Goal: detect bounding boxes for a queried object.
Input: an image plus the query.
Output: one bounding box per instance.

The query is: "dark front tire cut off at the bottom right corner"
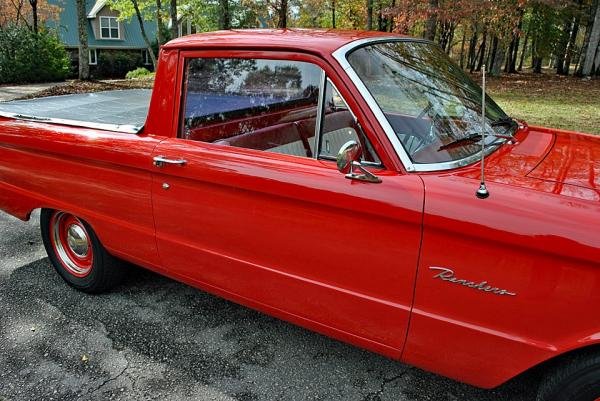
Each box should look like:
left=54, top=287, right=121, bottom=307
left=537, top=351, right=600, bottom=401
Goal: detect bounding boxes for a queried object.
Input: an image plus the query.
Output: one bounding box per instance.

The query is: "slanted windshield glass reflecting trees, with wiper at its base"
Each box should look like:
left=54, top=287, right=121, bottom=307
left=348, top=41, right=516, bottom=163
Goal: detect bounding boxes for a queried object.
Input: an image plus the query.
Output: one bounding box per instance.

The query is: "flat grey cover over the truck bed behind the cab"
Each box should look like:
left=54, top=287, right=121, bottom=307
left=0, top=89, right=152, bottom=134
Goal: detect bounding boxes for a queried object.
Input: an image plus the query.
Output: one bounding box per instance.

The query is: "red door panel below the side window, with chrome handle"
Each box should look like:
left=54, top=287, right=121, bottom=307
left=153, top=139, right=423, bottom=353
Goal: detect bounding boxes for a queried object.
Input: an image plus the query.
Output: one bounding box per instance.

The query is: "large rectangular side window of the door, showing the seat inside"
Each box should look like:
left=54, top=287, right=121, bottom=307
left=179, top=58, right=323, bottom=157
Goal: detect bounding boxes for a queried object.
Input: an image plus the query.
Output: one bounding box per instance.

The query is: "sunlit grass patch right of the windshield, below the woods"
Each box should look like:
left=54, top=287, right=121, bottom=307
left=486, top=73, right=600, bottom=135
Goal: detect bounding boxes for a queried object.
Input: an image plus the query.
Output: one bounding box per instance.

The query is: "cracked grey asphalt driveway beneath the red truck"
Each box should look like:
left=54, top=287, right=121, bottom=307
left=0, top=212, right=535, bottom=401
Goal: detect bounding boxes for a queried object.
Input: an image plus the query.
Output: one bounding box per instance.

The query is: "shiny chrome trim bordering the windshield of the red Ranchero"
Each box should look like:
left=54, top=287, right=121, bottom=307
left=331, top=36, right=500, bottom=172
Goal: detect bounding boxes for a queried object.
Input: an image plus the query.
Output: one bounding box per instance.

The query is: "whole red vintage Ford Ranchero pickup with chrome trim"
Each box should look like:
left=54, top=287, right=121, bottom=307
left=0, top=30, right=600, bottom=401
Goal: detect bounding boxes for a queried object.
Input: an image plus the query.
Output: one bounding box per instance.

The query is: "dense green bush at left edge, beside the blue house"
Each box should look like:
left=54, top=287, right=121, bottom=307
left=0, top=25, right=70, bottom=84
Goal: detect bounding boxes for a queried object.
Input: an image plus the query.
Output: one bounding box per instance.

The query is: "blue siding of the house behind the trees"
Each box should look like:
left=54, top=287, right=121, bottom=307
left=47, top=0, right=156, bottom=49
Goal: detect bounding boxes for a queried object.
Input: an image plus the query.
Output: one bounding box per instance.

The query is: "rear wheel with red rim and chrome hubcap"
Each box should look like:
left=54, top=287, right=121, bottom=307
left=40, top=209, right=123, bottom=294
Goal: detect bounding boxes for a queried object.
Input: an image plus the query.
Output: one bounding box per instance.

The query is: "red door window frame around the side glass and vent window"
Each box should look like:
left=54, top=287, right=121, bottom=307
left=171, top=48, right=398, bottom=170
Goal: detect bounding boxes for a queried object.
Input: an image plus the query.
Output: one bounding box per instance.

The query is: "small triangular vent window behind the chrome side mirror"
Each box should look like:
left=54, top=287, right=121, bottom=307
left=319, top=79, right=381, bottom=164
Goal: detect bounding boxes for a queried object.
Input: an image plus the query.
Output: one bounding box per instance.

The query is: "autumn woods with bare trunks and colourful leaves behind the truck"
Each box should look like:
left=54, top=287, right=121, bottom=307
left=0, top=0, right=600, bottom=77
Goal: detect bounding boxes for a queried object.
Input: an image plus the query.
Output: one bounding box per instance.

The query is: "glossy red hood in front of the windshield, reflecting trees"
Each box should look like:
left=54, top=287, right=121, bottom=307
left=459, top=127, right=600, bottom=201
